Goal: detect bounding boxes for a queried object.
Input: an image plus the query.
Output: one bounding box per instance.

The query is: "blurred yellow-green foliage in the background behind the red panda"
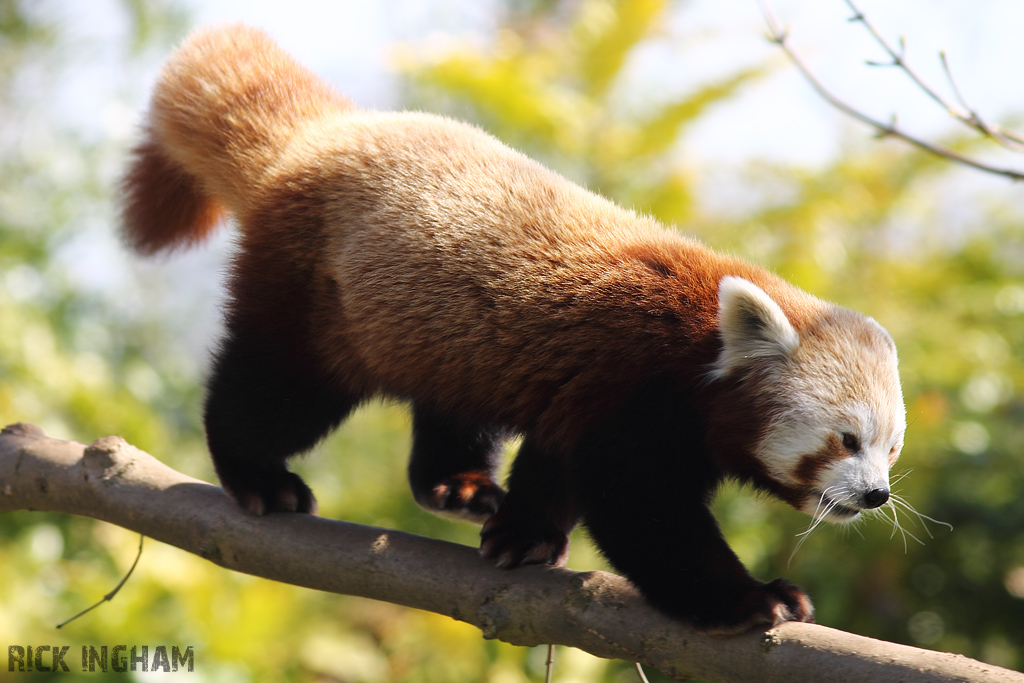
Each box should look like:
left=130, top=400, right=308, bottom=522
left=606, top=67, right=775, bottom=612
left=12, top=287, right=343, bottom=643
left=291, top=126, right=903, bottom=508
left=0, top=0, right=1024, bottom=682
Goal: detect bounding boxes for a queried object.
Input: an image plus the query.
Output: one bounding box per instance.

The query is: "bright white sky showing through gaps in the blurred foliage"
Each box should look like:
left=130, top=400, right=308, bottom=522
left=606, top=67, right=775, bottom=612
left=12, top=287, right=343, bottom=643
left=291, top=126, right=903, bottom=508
left=12, top=0, right=1024, bottom=393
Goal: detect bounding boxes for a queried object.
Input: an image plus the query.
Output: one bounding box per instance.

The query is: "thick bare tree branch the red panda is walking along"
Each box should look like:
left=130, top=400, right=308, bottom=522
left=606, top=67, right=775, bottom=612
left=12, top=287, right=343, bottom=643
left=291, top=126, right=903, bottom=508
left=0, top=425, right=1024, bottom=683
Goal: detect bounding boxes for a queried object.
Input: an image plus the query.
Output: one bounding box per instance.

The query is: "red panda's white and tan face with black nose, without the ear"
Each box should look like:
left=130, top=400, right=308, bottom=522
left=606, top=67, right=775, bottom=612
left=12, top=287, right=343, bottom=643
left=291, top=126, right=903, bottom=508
left=741, top=301, right=906, bottom=521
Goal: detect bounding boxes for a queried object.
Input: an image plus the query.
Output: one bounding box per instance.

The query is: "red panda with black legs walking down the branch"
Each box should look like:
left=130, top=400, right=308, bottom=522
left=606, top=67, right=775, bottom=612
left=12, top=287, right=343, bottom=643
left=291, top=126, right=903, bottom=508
left=123, top=26, right=905, bottom=633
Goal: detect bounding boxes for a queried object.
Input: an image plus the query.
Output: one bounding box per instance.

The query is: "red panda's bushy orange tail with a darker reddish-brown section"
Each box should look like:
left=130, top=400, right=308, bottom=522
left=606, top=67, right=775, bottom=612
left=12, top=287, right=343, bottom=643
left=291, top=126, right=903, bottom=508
left=122, top=26, right=351, bottom=254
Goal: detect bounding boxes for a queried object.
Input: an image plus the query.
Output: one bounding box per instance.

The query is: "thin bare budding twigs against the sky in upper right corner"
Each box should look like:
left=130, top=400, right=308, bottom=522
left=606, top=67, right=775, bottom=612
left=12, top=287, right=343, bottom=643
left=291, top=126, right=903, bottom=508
left=761, top=0, right=1024, bottom=180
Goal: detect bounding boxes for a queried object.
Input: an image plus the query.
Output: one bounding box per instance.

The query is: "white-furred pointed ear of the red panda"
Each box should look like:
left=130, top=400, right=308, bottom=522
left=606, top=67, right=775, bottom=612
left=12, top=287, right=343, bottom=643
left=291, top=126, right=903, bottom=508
left=714, top=275, right=800, bottom=377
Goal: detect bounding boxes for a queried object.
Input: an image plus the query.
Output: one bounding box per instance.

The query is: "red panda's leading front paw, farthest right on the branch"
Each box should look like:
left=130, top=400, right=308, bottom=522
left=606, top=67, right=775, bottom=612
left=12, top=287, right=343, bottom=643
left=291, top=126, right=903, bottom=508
left=691, top=579, right=814, bottom=636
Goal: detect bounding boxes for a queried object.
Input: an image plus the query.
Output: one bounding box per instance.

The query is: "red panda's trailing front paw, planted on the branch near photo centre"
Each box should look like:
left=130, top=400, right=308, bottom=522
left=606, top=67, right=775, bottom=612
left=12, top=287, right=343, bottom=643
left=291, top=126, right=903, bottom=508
left=480, top=507, right=569, bottom=569
